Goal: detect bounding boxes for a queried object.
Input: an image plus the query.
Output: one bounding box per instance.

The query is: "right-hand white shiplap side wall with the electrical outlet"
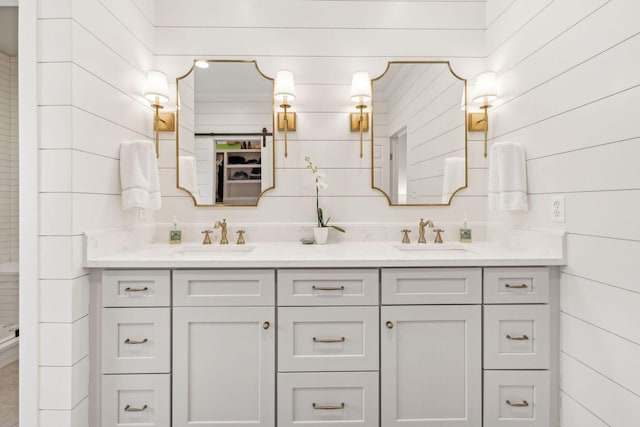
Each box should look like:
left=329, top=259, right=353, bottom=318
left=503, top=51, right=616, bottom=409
left=487, top=0, right=640, bottom=427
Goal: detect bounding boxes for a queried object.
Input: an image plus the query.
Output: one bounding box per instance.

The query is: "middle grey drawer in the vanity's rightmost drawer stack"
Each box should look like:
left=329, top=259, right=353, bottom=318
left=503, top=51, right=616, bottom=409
left=484, top=305, right=551, bottom=369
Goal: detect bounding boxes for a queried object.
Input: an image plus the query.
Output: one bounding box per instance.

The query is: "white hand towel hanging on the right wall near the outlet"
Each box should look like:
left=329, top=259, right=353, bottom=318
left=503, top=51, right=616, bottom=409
left=489, top=142, right=529, bottom=211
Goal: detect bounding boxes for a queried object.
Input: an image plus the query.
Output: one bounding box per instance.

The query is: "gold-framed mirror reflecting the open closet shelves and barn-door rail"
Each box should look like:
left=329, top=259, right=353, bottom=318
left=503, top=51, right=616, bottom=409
left=176, top=60, right=275, bottom=206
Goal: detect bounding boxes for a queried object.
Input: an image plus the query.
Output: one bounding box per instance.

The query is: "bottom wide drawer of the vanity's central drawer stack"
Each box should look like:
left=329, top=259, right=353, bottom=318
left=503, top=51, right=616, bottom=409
left=278, top=372, right=378, bottom=427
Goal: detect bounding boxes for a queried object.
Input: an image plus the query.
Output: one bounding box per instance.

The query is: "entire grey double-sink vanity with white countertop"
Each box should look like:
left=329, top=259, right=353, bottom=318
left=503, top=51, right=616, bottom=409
left=88, top=234, right=563, bottom=427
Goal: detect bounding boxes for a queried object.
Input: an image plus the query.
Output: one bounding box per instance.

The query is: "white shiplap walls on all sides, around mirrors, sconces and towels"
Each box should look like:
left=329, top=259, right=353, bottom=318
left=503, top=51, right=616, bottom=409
left=31, top=0, right=640, bottom=427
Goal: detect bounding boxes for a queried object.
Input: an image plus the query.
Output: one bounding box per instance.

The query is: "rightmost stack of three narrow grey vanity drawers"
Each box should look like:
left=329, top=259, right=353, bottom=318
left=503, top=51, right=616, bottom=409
left=483, top=267, right=552, bottom=427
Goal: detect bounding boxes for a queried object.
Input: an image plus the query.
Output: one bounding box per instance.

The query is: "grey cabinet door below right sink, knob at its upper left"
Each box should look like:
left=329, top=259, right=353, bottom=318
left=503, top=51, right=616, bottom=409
left=380, top=305, right=482, bottom=427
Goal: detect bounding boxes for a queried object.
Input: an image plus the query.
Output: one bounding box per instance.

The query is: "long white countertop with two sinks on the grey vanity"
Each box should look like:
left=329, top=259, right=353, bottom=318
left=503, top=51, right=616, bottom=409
left=85, top=241, right=565, bottom=268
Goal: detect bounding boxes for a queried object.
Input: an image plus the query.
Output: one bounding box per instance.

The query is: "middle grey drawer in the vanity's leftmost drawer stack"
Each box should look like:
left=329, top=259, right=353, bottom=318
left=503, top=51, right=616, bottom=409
left=102, top=307, right=171, bottom=374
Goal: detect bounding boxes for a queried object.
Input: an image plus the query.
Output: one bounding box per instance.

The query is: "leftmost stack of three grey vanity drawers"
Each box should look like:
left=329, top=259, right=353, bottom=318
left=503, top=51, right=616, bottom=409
left=100, top=270, right=171, bottom=427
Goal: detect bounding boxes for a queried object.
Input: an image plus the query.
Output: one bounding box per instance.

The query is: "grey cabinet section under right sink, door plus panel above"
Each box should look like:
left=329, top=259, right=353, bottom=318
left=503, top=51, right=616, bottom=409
left=380, top=268, right=482, bottom=427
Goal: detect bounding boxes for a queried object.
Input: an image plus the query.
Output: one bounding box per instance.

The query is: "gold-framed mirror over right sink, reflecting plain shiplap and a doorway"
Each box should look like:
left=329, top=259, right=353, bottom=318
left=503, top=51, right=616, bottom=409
left=371, top=61, right=467, bottom=206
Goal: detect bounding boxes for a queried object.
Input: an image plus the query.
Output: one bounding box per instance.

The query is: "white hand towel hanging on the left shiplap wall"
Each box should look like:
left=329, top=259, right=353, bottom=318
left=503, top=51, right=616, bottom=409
left=120, top=140, right=161, bottom=210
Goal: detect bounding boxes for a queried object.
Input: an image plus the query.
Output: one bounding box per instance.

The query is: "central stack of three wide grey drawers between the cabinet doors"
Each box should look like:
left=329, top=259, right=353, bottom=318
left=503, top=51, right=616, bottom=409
left=277, top=269, right=379, bottom=427
